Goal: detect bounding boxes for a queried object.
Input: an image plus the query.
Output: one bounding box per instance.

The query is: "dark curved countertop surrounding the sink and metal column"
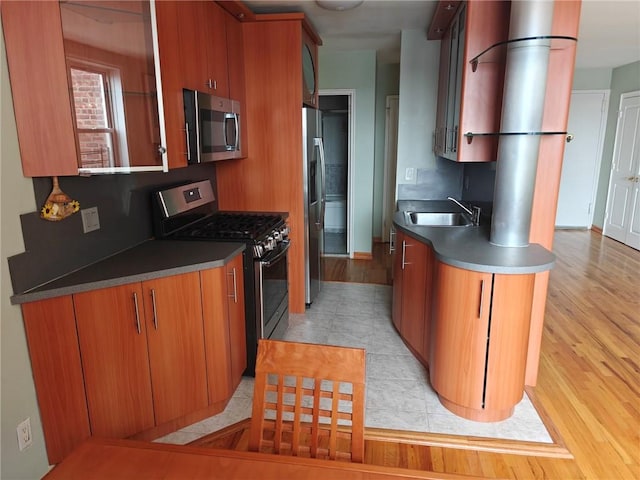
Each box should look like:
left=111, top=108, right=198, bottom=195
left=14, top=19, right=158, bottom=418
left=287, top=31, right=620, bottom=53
left=393, top=200, right=556, bottom=274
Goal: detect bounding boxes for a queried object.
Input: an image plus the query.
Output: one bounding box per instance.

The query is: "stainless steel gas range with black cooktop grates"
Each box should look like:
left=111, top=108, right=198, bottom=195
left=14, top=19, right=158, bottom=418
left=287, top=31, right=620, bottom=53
left=153, top=180, right=291, bottom=375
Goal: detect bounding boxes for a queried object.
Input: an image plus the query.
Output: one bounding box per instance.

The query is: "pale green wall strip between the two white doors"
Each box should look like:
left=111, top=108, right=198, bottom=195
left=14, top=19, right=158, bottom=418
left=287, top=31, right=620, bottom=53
left=593, top=62, right=640, bottom=228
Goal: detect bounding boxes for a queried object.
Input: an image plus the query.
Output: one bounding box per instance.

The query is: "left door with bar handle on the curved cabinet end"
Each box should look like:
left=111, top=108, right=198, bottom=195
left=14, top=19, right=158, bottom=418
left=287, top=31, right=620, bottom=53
left=429, top=262, right=492, bottom=409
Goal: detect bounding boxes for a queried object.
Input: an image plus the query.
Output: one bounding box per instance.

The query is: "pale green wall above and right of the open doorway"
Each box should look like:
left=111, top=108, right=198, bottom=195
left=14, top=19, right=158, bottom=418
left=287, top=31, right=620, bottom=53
left=318, top=47, right=376, bottom=253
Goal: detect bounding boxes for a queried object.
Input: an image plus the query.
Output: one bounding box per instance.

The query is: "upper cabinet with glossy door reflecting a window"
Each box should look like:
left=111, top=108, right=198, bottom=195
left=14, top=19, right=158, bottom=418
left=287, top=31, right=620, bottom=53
left=2, top=1, right=167, bottom=176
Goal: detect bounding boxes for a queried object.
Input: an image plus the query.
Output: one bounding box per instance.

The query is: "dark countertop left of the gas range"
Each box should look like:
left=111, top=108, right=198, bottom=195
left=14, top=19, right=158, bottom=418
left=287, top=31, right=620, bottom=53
left=11, top=240, right=245, bottom=305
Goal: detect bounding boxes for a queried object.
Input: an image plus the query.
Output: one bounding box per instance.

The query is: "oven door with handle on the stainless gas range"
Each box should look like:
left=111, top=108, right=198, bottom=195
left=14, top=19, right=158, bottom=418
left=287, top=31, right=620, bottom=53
left=256, top=240, right=290, bottom=339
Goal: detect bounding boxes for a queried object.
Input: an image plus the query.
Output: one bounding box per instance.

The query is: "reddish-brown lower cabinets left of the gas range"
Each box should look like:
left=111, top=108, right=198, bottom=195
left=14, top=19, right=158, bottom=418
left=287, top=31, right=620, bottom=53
left=22, top=255, right=246, bottom=464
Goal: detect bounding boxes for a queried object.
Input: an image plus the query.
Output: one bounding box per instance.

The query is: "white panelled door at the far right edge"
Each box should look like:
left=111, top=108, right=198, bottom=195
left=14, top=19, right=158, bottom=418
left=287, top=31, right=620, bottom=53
left=604, top=91, right=640, bottom=250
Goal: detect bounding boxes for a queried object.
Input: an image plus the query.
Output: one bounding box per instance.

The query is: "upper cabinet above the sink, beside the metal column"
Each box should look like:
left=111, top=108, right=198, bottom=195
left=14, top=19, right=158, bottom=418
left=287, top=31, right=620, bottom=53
left=433, top=1, right=511, bottom=162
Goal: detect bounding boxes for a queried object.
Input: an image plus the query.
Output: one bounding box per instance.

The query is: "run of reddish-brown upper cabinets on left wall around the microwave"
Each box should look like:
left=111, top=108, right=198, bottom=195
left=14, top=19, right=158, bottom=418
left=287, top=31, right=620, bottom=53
left=1, top=0, right=246, bottom=177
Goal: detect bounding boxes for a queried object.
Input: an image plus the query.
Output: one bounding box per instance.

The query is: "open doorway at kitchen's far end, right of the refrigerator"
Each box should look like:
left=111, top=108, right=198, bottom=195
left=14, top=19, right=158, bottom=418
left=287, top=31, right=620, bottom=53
left=319, top=90, right=353, bottom=256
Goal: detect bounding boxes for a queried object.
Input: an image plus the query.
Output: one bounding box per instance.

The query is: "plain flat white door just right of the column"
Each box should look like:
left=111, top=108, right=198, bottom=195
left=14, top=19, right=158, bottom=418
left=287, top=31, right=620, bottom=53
left=556, top=90, right=609, bottom=228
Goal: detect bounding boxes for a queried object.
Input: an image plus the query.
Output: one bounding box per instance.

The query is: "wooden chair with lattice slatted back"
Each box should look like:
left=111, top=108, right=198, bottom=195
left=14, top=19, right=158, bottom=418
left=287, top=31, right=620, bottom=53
left=249, top=340, right=365, bottom=463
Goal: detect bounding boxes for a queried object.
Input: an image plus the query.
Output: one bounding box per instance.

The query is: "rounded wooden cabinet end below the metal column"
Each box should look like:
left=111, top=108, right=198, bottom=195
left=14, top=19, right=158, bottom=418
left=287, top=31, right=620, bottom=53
left=429, top=262, right=535, bottom=422
